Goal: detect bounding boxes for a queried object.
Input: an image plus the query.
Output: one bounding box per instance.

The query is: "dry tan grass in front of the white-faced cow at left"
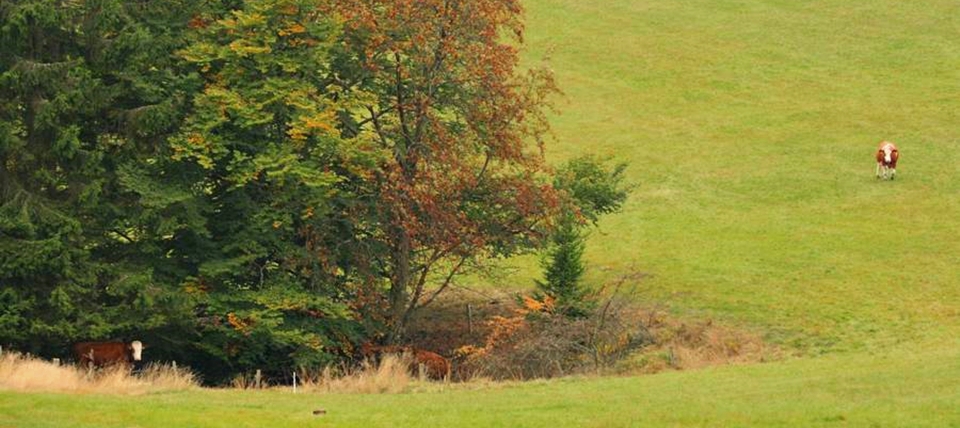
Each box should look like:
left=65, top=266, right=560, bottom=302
left=0, top=352, right=197, bottom=395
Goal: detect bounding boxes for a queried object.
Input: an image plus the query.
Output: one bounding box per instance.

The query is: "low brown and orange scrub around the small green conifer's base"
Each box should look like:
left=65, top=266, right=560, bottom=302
left=457, top=274, right=779, bottom=380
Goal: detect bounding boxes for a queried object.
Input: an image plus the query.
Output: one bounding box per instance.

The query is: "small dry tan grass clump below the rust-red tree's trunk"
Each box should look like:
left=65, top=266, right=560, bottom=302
left=302, top=354, right=416, bottom=394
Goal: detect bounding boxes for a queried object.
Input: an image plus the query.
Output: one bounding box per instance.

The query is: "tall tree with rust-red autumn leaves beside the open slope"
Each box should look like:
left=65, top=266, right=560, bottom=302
left=330, top=0, right=557, bottom=340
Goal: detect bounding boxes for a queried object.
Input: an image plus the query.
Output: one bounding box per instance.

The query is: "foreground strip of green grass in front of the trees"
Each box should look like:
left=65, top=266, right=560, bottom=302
left=0, top=343, right=960, bottom=428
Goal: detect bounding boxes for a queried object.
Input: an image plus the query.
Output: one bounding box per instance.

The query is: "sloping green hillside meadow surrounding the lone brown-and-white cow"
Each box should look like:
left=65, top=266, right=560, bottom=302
left=529, top=0, right=960, bottom=353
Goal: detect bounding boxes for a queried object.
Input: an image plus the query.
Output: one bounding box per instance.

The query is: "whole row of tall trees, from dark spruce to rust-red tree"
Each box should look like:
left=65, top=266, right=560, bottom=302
left=0, top=0, right=622, bottom=380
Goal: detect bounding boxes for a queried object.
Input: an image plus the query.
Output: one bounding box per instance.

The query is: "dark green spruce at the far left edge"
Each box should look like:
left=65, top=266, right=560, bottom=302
left=0, top=0, right=199, bottom=356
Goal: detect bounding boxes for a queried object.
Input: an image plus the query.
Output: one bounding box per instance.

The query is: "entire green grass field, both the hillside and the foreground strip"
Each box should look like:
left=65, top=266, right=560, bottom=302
left=0, top=0, right=960, bottom=427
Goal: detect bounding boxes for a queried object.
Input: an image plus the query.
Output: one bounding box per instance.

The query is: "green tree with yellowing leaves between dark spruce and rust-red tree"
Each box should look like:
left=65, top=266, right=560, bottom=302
left=165, top=0, right=377, bottom=371
